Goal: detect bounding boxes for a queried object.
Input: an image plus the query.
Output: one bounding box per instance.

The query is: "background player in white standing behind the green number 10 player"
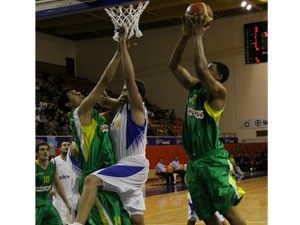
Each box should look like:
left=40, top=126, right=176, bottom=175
left=52, top=141, right=79, bottom=224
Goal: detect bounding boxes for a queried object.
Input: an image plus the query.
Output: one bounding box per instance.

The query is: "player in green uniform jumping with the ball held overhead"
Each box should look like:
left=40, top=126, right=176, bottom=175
left=169, top=17, right=246, bottom=225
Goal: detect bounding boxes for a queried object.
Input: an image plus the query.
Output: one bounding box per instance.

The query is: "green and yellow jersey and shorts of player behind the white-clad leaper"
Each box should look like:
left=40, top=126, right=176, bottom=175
left=68, top=108, right=131, bottom=225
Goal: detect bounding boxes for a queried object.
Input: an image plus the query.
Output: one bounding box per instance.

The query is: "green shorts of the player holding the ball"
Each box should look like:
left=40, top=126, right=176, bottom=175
left=186, top=151, right=245, bottom=220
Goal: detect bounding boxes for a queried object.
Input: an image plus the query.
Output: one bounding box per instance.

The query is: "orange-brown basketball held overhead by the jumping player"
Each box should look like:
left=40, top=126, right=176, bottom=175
left=185, top=2, right=213, bottom=27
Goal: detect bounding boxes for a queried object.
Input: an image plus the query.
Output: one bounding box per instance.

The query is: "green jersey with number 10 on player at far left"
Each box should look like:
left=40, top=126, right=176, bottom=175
left=35, top=161, right=56, bottom=207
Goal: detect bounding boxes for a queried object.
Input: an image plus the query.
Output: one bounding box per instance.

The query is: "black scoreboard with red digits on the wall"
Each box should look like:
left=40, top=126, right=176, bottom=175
left=244, top=21, right=268, bottom=64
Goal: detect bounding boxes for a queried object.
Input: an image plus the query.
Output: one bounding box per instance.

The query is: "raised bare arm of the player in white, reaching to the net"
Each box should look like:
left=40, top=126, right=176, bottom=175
left=120, top=30, right=145, bottom=126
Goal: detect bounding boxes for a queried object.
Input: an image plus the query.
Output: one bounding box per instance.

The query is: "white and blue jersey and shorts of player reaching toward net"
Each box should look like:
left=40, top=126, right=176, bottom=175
left=93, top=103, right=149, bottom=215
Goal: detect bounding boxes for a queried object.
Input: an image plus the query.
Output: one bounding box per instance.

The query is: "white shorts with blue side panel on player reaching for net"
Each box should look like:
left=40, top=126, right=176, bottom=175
left=93, top=155, right=149, bottom=215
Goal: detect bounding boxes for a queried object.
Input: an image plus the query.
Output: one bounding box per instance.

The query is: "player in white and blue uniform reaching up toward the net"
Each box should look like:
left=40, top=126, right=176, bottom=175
left=70, top=31, right=149, bottom=225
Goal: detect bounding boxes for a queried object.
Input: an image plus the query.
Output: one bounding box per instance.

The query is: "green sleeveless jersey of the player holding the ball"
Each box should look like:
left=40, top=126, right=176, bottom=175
left=182, top=83, right=224, bottom=159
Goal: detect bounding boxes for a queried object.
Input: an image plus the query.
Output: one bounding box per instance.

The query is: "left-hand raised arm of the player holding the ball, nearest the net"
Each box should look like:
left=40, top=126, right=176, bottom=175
left=169, top=17, right=199, bottom=90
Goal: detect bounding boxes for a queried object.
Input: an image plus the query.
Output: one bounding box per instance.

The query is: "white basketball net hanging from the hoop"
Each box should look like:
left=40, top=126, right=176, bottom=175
left=104, top=1, right=149, bottom=42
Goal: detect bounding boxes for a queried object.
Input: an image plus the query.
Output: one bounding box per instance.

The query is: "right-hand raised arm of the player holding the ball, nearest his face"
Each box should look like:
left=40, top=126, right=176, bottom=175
left=194, top=26, right=227, bottom=110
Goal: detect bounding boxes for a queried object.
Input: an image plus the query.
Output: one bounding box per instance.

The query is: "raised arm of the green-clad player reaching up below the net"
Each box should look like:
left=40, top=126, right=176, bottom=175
left=78, top=50, right=120, bottom=125
